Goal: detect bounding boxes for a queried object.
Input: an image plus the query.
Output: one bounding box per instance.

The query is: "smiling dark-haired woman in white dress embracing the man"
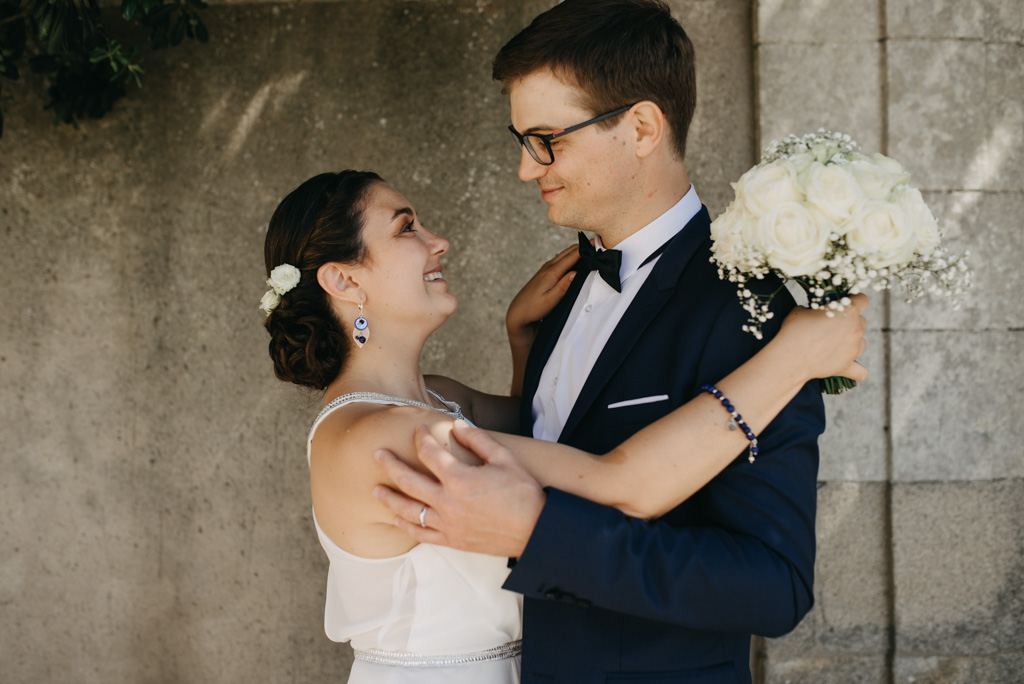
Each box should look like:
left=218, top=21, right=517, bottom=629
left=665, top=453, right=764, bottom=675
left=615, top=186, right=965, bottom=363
left=262, top=171, right=867, bottom=684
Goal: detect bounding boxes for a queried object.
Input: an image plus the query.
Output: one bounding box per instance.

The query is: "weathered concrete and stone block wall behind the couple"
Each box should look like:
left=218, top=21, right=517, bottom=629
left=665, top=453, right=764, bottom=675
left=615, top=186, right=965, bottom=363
left=0, top=0, right=1024, bottom=683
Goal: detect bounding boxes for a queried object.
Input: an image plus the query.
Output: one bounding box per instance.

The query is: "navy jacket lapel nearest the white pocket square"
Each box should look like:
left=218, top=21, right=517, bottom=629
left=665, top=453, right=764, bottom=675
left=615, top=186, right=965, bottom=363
left=557, top=206, right=711, bottom=441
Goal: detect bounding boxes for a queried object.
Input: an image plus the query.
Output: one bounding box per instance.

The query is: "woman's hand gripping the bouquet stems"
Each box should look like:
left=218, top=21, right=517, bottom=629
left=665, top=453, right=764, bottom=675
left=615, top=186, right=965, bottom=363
left=772, top=295, right=867, bottom=381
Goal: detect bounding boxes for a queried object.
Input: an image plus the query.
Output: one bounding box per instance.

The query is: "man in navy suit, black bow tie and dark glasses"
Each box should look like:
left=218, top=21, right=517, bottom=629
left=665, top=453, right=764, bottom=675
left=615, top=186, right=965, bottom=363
left=383, top=0, right=824, bottom=683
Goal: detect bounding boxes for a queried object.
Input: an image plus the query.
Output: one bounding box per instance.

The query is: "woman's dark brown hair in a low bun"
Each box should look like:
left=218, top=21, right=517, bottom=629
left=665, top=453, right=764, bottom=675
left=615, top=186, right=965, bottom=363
left=263, top=171, right=383, bottom=389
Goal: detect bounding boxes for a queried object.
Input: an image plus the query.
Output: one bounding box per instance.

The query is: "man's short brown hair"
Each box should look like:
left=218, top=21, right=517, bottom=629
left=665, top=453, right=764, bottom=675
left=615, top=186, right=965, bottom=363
left=492, top=0, right=696, bottom=160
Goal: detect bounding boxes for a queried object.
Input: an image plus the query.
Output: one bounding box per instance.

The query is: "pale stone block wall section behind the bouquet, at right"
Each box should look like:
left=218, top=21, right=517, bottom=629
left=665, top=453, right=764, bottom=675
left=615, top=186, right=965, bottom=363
left=755, top=0, right=1024, bottom=684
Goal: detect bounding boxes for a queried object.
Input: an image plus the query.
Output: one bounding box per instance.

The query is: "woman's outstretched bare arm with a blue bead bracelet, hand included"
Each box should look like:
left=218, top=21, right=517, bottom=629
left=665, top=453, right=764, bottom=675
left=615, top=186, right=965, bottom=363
left=454, top=296, right=867, bottom=518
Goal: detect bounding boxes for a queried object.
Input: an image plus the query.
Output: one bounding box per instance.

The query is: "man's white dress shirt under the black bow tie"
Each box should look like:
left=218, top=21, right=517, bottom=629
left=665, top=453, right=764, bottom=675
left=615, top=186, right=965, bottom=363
left=531, top=185, right=700, bottom=441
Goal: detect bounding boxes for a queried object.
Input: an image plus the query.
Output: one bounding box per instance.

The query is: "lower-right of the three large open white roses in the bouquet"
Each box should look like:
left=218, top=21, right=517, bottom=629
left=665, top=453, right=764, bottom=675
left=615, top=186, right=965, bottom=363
left=846, top=200, right=918, bottom=268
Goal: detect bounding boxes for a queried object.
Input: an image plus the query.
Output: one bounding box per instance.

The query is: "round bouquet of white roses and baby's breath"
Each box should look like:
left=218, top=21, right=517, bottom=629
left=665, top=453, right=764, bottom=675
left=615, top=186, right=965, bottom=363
left=711, top=129, right=972, bottom=394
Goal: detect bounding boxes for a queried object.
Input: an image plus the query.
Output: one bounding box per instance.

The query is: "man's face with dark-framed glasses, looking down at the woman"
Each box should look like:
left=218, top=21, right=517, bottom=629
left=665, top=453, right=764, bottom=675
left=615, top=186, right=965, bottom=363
left=509, top=69, right=636, bottom=234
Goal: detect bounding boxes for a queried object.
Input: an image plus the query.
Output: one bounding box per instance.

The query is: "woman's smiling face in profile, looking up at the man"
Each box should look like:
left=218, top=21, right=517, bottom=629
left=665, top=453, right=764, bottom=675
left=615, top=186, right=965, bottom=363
left=359, top=183, right=458, bottom=327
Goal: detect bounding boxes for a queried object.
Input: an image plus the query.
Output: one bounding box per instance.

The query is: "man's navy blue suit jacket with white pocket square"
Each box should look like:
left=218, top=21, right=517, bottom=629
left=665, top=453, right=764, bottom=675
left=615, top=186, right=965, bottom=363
left=505, top=208, right=824, bottom=684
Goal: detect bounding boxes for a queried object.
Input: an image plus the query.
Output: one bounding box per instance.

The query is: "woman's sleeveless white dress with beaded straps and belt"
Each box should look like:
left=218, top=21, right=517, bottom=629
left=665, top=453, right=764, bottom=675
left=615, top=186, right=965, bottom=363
left=306, top=392, right=522, bottom=684
